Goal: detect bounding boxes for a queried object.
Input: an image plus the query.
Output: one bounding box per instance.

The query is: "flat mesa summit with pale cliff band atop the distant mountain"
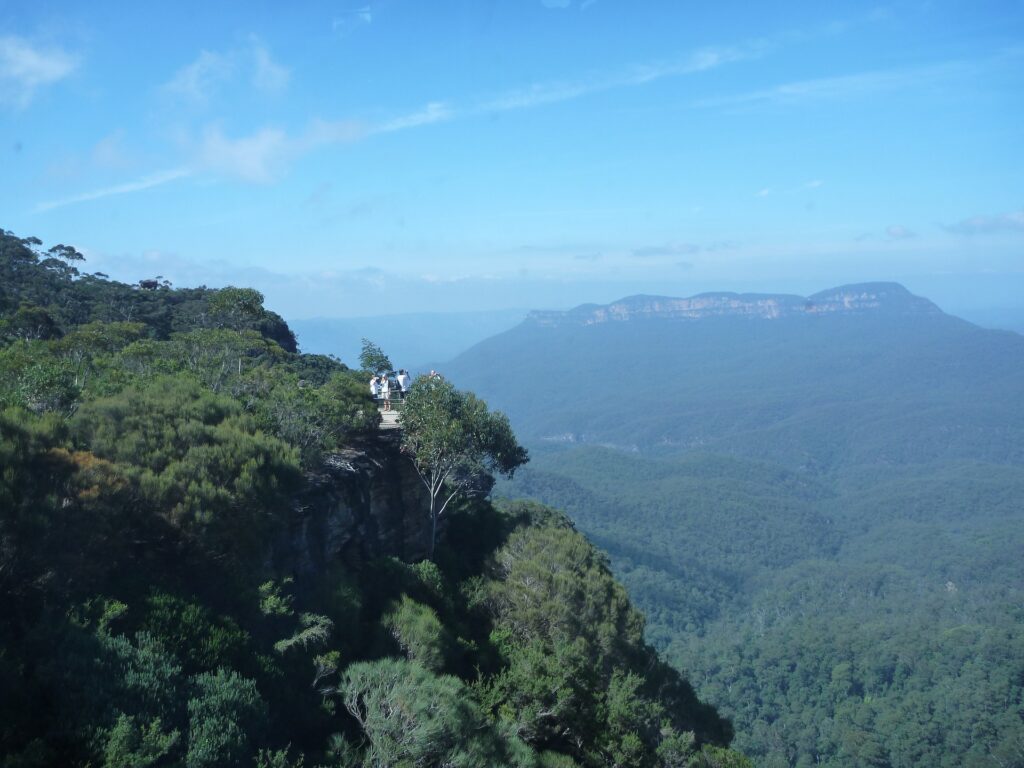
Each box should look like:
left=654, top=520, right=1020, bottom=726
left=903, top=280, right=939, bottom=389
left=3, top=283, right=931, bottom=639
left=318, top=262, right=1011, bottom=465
left=526, top=283, right=942, bottom=326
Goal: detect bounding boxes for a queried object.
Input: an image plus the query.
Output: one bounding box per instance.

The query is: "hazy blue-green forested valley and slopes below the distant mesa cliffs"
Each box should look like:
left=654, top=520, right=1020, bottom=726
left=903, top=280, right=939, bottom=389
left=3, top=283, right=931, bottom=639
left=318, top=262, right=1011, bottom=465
left=445, top=286, right=1024, bottom=768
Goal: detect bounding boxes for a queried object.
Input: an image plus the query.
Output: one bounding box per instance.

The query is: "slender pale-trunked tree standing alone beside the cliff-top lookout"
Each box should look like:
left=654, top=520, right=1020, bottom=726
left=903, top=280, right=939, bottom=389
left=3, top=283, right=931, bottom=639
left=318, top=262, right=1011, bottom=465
left=399, top=376, right=528, bottom=559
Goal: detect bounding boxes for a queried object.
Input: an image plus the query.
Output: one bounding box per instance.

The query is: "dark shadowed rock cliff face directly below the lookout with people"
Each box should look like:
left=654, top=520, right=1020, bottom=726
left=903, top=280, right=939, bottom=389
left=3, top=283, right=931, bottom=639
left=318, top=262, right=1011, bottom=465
left=274, top=433, right=430, bottom=573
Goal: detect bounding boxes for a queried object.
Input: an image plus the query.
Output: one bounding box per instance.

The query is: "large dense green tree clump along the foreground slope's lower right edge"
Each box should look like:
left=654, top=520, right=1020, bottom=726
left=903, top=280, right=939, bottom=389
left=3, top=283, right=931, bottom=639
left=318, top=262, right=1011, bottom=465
left=475, top=503, right=730, bottom=766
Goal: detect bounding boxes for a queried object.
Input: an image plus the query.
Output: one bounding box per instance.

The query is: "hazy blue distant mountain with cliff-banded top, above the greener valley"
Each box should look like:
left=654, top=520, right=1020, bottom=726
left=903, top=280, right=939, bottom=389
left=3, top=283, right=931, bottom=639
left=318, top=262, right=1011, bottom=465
left=445, top=284, right=1024, bottom=466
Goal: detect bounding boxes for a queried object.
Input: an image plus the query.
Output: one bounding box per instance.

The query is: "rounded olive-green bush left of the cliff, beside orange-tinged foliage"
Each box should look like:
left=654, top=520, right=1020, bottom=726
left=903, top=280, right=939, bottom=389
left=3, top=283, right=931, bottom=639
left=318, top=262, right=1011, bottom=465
left=72, top=378, right=300, bottom=559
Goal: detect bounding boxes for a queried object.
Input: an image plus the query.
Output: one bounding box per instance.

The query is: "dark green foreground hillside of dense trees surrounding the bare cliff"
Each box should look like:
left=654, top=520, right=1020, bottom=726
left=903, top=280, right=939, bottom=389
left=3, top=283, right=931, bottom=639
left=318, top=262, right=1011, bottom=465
left=0, top=231, right=749, bottom=768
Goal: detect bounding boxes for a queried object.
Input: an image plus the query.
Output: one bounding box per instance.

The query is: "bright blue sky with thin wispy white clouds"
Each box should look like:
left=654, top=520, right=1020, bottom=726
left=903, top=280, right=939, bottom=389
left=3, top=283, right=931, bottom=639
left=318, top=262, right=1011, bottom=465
left=0, top=0, right=1024, bottom=318
